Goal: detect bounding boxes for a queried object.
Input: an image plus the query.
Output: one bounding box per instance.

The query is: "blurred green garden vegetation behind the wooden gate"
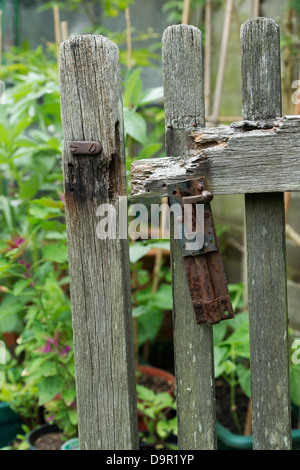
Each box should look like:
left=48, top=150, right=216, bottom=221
left=0, top=0, right=300, bottom=448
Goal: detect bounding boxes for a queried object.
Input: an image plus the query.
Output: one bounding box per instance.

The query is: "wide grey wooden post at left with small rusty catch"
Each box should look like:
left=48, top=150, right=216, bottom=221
left=60, top=35, right=138, bottom=450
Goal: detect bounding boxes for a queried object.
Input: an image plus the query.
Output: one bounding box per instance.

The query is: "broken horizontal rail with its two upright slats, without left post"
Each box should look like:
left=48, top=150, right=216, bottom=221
left=131, top=18, right=300, bottom=450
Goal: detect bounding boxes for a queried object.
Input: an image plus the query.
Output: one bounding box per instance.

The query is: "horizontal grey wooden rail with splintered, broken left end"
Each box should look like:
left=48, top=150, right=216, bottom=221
left=131, top=116, right=300, bottom=197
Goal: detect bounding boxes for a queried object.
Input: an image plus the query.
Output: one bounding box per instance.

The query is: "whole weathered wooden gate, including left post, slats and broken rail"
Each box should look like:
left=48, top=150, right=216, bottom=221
left=60, top=18, right=300, bottom=450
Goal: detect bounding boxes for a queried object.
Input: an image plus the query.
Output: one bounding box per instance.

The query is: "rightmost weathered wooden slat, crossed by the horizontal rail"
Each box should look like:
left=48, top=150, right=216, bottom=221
left=241, top=18, right=291, bottom=450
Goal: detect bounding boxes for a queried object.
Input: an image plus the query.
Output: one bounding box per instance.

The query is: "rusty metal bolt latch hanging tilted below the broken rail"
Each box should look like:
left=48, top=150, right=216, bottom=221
left=168, top=178, right=234, bottom=324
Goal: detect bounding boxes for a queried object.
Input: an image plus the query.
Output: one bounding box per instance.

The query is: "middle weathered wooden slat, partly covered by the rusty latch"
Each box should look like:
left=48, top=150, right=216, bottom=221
left=163, top=25, right=216, bottom=449
